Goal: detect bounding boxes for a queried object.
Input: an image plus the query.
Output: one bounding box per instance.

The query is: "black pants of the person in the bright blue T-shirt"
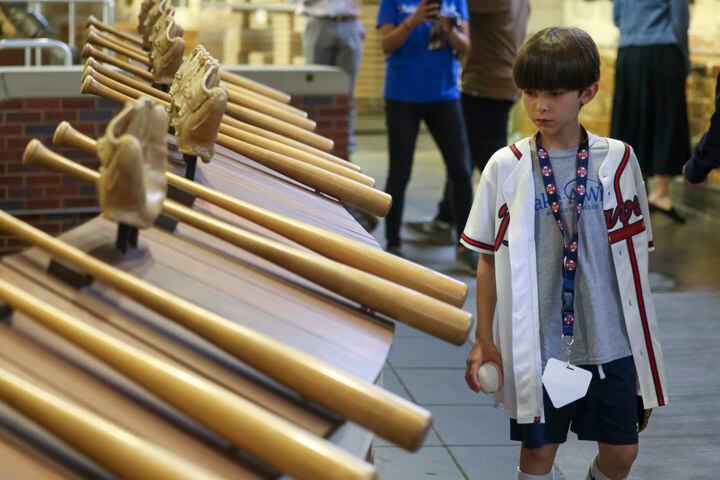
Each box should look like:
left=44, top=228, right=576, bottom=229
left=385, top=100, right=472, bottom=246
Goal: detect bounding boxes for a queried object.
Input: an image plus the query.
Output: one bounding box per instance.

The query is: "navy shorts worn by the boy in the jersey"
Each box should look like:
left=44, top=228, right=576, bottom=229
left=510, top=356, right=638, bottom=448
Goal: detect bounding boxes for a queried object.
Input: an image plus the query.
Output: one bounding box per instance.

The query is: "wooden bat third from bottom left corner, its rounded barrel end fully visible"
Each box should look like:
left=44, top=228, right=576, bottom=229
left=0, top=202, right=431, bottom=450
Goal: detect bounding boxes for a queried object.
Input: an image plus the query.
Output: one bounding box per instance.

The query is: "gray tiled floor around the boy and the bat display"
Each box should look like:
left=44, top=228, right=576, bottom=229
left=353, top=114, right=720, bottom=480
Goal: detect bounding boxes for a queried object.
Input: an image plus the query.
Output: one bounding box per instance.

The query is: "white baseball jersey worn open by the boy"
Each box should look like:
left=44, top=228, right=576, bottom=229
left=460, top=133, right=668, bottom=423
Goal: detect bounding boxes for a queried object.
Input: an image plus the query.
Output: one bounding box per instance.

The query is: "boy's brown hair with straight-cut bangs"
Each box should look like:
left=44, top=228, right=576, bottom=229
left=513, top=27, right=600, bottom=92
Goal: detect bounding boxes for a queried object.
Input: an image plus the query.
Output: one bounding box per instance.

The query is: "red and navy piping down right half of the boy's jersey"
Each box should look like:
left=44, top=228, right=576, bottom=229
left=611, top=144, right=666, bottom=407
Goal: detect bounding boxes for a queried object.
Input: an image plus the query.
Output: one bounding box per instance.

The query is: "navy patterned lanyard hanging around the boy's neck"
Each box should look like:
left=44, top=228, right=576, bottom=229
left=535, top=129, right=590, bottom=342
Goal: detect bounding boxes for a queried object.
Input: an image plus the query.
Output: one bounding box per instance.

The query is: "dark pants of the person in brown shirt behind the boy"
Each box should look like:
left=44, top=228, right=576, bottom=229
left=436, top=93, right=515, bottom=224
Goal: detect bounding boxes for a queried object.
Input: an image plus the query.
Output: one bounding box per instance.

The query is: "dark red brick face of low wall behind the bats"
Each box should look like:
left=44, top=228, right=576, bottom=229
left=0, top=90, right=348, bottom=255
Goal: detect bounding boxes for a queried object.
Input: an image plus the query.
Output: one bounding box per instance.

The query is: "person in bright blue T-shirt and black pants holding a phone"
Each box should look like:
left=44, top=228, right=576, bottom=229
left=377, top=0, right=477, bottom=274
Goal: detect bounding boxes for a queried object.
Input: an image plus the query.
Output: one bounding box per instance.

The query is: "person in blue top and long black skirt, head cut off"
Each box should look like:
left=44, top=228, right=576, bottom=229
left=610, top=0, right=690, bottom=223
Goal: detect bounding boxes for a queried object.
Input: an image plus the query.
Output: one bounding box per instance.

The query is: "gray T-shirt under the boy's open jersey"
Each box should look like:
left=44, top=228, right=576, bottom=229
left=531, top=138, right=631, bottom=369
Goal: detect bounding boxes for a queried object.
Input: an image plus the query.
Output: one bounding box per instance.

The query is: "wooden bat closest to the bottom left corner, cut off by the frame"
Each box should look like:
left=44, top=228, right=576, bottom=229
left=0, top=362, right=221, bottom=480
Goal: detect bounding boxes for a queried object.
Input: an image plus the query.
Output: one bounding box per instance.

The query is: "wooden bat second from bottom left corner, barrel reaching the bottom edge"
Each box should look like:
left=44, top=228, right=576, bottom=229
left=0, top=280, right=375, bottom=480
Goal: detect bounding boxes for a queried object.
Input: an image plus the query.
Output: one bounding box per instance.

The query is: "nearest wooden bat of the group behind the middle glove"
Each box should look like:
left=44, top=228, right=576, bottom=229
left=81, top=75, right=392, bottom=217
